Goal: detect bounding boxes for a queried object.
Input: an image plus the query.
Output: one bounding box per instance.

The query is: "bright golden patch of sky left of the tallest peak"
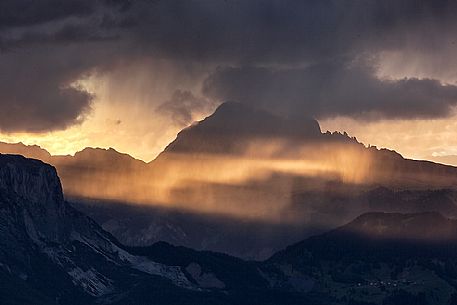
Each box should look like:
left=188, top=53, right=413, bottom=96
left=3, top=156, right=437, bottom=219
left=0, top=68, right=213, bottom=161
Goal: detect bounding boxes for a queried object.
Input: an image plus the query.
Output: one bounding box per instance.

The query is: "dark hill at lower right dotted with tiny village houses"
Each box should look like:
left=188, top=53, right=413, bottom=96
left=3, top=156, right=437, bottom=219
left=264, top=212, right=457, bottom=304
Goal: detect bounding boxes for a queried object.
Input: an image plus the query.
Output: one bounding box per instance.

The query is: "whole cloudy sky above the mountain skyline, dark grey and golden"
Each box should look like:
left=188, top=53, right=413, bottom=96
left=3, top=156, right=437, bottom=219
left=0, top=0, right=457, bottom=160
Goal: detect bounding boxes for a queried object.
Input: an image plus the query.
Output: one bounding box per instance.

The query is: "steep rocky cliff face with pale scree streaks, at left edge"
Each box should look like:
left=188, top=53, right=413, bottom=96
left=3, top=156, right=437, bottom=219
left=0, top=155, right=210, bottom=302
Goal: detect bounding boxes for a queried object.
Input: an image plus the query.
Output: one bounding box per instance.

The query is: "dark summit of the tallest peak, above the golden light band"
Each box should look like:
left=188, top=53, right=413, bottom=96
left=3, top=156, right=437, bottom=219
left=159, top=102, right=321, bottom=158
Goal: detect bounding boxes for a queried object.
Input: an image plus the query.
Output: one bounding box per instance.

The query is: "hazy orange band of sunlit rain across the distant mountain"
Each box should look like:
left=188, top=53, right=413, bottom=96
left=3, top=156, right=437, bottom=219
left=54, top=140, right=374, bottom=222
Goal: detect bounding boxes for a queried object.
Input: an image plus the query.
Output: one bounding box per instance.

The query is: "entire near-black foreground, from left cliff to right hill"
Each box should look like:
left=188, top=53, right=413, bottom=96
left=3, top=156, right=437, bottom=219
left=0, top=155, right=457, bottom=305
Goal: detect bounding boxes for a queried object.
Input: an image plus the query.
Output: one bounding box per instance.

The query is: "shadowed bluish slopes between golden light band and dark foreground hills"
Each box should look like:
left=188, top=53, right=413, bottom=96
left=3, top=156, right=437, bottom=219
left=72, top=188, right=457, bottom=259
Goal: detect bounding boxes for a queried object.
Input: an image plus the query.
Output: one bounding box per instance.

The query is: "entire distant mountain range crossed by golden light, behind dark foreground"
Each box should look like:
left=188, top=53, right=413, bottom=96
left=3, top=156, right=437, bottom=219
left=0, top=103, right=457, bottom=258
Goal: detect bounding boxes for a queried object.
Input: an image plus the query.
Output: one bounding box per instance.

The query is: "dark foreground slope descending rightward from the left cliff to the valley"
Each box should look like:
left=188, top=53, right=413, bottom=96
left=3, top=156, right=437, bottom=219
left=0, top=154, right=314, bottom=304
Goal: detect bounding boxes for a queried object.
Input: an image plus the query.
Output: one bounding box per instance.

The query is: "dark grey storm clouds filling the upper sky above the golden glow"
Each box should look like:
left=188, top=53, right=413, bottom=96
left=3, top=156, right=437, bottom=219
left=0, top=0, right=457, bottom=132
